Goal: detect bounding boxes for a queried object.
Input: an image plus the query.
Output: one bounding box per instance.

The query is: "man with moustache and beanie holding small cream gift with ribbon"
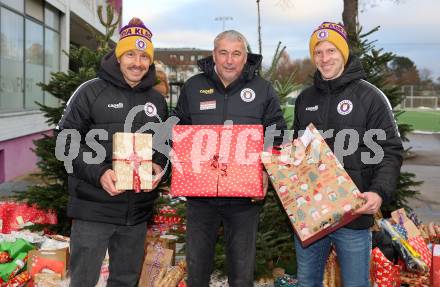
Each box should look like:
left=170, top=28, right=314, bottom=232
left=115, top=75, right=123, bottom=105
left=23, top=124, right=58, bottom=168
left=57, top=18, right=167, bottom=287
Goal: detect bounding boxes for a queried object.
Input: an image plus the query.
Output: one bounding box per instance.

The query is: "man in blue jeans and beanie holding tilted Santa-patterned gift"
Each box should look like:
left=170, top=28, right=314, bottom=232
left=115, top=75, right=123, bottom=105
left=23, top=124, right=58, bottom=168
left=293, top=22, right=403, bottom=287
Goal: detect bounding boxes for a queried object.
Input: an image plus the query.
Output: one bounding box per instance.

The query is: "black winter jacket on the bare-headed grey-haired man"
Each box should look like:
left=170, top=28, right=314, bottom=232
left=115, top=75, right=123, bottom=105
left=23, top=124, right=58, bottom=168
left=172, top=54, right=286, bottom=202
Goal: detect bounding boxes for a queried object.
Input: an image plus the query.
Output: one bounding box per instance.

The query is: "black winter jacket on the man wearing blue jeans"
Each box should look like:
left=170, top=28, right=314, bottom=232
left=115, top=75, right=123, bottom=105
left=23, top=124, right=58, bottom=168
left=293, top=57, right=403, bottom=229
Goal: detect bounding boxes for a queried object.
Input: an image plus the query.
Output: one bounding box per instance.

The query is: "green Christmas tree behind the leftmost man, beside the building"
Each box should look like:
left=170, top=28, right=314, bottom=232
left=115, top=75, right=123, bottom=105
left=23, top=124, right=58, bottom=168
left=13, top=5, right=120, bottom=235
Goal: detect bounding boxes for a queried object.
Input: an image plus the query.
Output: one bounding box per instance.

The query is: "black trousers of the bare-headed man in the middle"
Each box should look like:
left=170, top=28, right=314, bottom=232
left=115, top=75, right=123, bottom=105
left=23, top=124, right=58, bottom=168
left=186, top=199, right=261, bottom=287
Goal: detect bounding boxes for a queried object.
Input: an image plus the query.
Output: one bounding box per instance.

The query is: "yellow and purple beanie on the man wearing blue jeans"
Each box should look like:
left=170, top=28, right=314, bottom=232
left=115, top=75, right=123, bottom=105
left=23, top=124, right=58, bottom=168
left=309, top=22, right=350, bottom=64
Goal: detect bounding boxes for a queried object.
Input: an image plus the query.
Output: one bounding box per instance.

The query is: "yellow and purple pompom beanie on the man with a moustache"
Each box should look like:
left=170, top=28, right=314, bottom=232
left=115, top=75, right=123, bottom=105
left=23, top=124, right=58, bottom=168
left=115, top=18, right=154, bottom=63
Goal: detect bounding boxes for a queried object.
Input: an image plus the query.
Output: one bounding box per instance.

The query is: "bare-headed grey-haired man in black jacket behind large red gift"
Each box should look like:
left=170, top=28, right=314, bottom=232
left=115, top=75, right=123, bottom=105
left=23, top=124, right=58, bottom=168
left=173, top=30, right=285, bottom=287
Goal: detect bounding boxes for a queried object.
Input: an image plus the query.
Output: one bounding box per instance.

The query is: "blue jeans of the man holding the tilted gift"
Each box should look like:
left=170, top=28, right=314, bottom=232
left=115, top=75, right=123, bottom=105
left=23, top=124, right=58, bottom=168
left=295, top=228, right=371, bottom=287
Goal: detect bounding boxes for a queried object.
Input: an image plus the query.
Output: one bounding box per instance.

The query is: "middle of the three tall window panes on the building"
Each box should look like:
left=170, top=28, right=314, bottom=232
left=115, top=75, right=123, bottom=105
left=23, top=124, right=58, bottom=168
left=25, top=19, right=44, bottom=109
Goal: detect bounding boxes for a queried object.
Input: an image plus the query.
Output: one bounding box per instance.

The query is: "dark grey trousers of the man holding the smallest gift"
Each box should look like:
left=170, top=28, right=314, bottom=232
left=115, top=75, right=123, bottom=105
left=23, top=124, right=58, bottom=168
left=69, top=219, right=147, bottom=287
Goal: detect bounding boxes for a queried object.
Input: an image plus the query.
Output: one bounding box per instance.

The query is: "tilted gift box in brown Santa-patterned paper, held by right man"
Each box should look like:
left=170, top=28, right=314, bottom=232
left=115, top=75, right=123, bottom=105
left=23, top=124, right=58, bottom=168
left=262, top=124, right=364, bottom=246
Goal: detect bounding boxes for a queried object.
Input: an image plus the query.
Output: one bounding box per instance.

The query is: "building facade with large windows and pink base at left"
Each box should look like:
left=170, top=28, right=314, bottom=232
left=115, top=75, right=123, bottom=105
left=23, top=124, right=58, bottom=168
left=0, top=0, right=122, bottom=183
